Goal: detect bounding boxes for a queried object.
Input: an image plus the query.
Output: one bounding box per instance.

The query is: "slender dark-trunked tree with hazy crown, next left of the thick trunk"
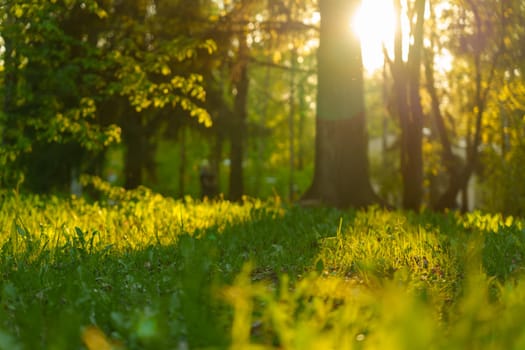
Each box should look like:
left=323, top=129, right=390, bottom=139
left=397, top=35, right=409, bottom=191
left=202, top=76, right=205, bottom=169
left=204, top=0, right=311, bottom=200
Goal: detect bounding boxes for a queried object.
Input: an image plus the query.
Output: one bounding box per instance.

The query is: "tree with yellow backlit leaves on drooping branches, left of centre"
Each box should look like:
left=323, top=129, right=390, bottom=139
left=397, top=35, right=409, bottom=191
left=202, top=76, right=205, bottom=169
left=106, top=0, right=215, bottom=188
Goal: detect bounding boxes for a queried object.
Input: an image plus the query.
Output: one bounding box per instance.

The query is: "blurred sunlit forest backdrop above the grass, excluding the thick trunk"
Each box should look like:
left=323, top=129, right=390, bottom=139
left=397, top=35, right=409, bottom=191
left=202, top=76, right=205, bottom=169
left=0, top=0, right=525, bottom=215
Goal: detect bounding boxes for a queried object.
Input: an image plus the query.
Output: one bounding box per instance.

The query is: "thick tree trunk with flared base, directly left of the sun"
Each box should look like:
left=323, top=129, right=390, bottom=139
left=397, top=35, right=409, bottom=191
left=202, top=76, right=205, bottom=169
left=303, top=0, right=378, bottom=207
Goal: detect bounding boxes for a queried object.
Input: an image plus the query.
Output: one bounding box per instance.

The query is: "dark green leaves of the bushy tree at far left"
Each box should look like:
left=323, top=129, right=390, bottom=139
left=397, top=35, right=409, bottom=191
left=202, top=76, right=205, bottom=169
left=1, top=1, right=119, bottom=157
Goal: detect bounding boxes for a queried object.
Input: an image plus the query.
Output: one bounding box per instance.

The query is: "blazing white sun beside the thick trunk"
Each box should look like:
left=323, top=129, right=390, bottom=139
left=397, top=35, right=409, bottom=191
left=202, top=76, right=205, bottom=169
left=350, top=0, right=398, bottom=73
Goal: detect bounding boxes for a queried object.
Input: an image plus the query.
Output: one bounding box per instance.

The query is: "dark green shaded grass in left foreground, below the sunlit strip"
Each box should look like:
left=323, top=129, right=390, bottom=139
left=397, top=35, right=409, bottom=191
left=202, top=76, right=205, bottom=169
left=0, top=204, right=348, bottom=349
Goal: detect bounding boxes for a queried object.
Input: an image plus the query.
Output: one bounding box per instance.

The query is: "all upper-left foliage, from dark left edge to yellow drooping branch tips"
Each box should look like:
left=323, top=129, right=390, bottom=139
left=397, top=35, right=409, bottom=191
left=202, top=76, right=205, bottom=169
left=0, top=1, right=216, bottom=191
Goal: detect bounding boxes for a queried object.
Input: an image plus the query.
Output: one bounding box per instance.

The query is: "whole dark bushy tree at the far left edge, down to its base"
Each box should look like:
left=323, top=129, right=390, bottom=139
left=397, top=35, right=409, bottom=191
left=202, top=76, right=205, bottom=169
left=0, top=0, right=119, bottom=191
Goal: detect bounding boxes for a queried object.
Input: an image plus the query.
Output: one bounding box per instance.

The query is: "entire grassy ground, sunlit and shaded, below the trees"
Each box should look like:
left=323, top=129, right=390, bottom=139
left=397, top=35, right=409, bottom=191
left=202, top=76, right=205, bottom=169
left=0, top=189, right=525, bottom=349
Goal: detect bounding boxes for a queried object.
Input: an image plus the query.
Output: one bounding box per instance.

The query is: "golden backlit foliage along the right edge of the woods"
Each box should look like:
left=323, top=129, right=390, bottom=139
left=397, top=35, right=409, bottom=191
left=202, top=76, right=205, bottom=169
left=432, top=1, right=525, bottom=214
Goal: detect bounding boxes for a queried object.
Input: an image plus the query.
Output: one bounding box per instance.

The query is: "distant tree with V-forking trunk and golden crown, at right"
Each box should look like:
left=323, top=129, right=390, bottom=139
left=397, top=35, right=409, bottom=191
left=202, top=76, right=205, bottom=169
left=434, top=0, right=506, bottom=210
